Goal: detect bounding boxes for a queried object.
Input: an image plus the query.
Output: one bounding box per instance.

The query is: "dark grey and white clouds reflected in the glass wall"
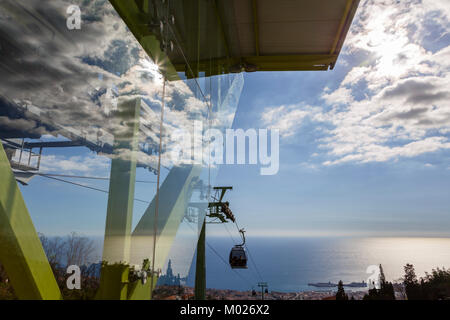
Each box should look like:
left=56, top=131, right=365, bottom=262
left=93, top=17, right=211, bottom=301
left=0, top=0, right=229, bottom=172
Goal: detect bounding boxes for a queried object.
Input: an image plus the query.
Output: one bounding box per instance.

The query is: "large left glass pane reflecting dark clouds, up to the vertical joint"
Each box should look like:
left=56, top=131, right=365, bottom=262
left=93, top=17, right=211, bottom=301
left=0, top=0, right=164, bottom=297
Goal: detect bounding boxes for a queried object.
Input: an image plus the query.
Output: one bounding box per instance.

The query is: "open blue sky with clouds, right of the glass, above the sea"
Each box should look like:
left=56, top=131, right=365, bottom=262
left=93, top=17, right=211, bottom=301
left=212, top=1, right=450, bottom=236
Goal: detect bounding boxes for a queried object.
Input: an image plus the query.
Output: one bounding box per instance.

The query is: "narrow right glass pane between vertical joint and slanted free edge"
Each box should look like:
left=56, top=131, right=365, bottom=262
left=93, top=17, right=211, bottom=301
left=156, top=1, right=243, bottom=285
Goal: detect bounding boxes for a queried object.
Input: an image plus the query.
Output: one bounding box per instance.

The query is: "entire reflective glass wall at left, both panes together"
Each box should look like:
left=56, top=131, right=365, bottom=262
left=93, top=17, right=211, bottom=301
left=0, top=0, right=243, bottom=299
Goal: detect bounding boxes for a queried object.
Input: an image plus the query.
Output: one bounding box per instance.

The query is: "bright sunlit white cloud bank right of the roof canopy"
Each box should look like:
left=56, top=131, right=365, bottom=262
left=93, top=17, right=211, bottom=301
left=303, top=0, right=450, bottom=165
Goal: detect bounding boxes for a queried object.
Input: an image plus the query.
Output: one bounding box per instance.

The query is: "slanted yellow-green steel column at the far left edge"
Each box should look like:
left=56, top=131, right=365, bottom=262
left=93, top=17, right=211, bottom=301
left=0, top=143, right=61, bottom=300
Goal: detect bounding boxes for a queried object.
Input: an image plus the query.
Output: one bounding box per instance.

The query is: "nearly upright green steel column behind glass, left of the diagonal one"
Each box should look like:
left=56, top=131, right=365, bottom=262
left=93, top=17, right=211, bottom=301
left=97, top=99, right=140, bottom=300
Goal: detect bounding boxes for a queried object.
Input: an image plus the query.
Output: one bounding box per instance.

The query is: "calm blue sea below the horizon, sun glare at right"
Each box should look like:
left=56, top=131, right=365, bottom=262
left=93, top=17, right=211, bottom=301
left=186, top=237, right=450, bottom=292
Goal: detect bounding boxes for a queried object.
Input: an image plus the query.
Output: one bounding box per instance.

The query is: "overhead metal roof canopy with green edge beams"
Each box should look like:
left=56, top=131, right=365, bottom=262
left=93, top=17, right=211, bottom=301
left=110, top=0, right=359, bottom=79
